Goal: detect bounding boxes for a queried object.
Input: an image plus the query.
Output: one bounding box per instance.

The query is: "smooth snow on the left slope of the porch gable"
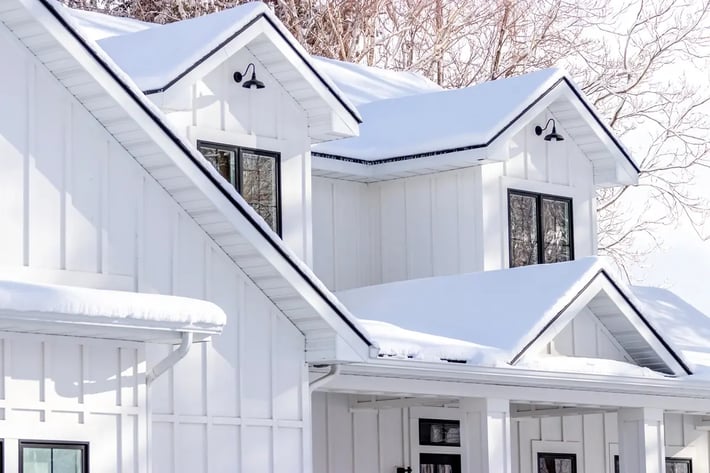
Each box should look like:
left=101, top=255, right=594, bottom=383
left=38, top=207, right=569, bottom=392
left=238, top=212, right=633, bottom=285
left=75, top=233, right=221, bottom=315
left=336, top=258, right=602, bottom=355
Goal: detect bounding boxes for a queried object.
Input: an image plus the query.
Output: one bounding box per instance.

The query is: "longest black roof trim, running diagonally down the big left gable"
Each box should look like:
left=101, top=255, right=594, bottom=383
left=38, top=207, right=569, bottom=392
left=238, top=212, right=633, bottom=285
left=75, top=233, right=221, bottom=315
left=39, top=0, right=373, bottom=347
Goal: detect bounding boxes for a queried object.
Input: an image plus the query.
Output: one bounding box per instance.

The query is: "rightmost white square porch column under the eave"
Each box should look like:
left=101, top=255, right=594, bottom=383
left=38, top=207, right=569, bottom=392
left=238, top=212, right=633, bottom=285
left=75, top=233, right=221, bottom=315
left=618, top=407, right=666, bottom=473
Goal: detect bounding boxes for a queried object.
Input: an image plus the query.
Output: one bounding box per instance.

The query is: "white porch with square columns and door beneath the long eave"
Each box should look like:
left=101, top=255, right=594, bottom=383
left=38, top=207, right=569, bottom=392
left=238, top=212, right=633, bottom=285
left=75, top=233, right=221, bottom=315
left=312, top=360, right=710, bottom=473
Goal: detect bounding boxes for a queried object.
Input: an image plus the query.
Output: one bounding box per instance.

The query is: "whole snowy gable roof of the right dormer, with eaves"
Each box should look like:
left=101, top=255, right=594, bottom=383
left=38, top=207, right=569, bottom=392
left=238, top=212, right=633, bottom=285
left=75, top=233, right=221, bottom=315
left=312, top=69, right=639, bottom=185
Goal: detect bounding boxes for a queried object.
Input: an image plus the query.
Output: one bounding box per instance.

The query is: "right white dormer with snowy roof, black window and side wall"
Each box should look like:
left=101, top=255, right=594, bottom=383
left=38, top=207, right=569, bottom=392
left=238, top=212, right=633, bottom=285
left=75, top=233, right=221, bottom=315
left=312, top=69, right=638, bottom=290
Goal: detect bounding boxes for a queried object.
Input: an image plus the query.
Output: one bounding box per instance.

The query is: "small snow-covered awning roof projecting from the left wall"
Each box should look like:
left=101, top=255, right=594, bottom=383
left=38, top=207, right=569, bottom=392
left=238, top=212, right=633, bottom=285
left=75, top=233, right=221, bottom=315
left=0, top=280, right=227, bottom=343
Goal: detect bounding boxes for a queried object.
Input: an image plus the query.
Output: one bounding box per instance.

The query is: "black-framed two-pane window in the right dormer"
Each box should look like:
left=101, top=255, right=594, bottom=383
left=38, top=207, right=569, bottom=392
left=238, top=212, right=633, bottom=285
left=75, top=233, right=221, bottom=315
left=508, top=189, right=574, bottom=268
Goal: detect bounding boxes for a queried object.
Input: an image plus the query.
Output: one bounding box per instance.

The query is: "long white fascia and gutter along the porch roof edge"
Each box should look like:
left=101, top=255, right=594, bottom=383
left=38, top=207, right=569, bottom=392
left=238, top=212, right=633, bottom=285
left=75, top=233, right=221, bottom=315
left=324, top=359, right=710, bottom=413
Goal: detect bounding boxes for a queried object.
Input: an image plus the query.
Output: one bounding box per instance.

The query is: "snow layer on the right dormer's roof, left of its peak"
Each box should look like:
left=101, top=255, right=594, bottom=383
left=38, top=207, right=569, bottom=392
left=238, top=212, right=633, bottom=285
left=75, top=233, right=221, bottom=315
left=312, top=69, right=565, bottom=161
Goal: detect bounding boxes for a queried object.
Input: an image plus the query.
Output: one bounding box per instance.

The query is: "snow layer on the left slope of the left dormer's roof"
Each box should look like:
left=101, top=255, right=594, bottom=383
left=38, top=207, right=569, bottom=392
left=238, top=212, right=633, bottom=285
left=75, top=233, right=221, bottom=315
left=99, top=2, right=269, bottom=90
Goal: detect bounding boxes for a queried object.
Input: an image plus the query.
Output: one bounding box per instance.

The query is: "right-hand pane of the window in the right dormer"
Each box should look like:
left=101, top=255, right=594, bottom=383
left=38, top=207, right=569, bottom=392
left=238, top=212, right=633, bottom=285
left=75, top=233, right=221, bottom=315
left=542, top=198, right=570, bottom=263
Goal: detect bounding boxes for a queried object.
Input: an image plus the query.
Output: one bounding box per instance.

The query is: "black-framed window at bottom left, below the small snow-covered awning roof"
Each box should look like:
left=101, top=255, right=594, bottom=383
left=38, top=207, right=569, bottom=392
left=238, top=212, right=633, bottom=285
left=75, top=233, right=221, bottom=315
left=19, top=441, right=89, bottom=473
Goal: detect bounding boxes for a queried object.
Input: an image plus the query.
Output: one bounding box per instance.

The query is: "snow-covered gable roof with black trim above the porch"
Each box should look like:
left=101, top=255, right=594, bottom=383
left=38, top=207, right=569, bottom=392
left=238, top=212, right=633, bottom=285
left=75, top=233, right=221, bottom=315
left=337, top=258, right=690, bottom=374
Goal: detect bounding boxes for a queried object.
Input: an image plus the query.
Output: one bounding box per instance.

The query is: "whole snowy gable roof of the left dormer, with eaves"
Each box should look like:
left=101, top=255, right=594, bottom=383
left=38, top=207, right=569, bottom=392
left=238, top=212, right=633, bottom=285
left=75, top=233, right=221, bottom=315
left=94, top=2, right=362, bottom=139
